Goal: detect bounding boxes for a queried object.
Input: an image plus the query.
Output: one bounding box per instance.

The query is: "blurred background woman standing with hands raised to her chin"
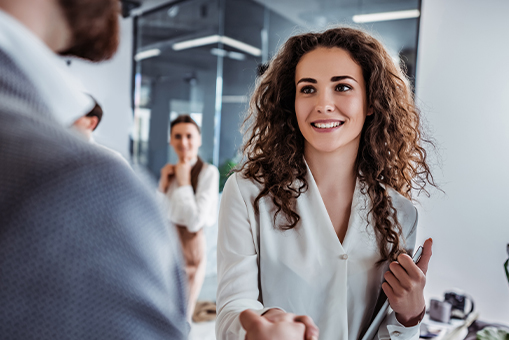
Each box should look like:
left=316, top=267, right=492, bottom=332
left=159, top=115, right=219, bottom=319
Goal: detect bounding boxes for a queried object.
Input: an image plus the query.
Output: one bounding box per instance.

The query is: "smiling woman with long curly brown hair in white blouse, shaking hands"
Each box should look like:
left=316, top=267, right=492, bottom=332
left=216, top=28, right=434, bottom=340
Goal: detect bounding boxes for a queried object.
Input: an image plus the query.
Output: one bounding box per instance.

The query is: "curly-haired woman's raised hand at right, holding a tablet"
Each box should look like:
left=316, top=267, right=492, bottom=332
left=382, top=239, right=433, bottom=327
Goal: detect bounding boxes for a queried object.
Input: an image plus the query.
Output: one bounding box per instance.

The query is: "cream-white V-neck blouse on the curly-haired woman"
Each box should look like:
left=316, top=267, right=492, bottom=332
left=216, top=168, right=419, bottom=340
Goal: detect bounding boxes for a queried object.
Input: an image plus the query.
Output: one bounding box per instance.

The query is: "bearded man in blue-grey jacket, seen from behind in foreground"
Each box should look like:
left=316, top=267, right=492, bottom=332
left=0, top=0, right=188, bottom=339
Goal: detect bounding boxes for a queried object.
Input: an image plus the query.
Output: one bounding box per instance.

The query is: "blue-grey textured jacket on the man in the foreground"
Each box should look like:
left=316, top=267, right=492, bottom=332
left=0, top=50, right=189, bottom=340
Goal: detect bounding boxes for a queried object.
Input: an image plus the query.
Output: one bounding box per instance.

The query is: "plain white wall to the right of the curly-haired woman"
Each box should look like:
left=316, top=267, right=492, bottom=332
left=417, top=0, right=509, bottom=324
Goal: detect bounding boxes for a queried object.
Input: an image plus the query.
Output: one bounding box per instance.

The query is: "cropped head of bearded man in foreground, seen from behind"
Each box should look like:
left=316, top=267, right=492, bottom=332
left=0, top=0, right=121, bottom=61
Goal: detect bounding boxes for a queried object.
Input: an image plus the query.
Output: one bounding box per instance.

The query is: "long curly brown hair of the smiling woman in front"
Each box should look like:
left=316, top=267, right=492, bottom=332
left=236, top=27, right=436, bottom=263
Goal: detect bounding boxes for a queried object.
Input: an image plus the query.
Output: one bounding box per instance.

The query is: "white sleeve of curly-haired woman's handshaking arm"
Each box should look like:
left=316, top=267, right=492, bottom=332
left=216, top=175, right=277, bottom=340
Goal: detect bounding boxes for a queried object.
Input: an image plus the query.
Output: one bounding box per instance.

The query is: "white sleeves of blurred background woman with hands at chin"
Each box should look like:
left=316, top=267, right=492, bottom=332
left=168, top=164, right=219, bottom=233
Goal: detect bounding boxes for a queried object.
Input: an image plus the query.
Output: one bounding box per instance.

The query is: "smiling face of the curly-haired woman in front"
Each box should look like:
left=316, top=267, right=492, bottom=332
left=295, top=47, right=371, bottom=152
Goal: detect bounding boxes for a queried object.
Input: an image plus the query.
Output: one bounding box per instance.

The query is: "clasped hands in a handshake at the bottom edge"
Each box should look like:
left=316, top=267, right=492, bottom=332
left=240, top=309, right=318, bottom=340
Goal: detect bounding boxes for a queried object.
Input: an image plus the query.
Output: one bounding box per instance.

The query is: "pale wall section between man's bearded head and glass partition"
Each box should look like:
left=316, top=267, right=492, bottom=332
left=69, top=18, right=133, bottom=159
